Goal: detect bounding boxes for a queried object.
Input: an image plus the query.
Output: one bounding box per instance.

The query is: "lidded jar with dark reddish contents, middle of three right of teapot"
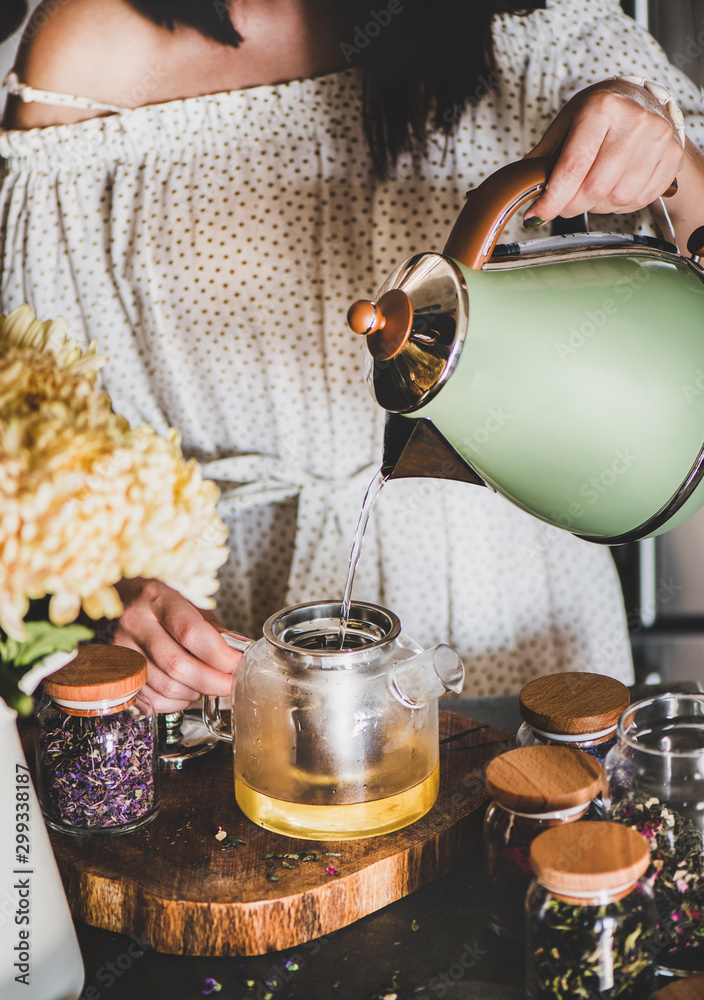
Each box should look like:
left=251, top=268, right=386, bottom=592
left=484, top=747, right=603, bottom=939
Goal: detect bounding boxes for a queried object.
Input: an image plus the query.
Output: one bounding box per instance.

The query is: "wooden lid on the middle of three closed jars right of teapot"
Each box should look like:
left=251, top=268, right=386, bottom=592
left=486, top=747, right=603, bottom=815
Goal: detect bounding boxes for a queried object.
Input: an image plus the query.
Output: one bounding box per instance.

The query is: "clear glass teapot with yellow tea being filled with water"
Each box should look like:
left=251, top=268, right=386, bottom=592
left=203, top=602, right=464, bottom=840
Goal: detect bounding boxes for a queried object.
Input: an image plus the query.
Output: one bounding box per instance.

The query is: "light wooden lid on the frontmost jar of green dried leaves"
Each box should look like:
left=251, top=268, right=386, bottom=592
left=530, top=820, right=650, bottom=894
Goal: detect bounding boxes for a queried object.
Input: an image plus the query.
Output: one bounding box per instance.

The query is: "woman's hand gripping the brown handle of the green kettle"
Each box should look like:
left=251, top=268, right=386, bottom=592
left=524, top=79, right=685, bottom=227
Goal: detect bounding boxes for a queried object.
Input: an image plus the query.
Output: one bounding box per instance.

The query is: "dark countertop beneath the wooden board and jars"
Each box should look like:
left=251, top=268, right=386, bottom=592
left=67, top=696, right=692, bottom=1000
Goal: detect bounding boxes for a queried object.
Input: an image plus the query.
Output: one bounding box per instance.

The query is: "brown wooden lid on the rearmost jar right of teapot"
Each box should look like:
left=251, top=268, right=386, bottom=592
left=519, top=670, right=631, bottom=735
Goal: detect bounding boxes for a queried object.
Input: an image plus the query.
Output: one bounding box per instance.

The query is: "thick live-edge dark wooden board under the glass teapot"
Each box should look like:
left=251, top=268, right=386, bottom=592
left=20, top=712, right=515, bottom=955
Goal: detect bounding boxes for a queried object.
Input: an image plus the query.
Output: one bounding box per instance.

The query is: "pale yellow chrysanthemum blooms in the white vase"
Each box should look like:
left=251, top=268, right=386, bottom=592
left=0, top=305, right=227, bottom=640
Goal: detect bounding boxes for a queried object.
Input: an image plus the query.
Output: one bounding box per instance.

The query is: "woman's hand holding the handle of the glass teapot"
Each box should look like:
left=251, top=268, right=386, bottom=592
left=112, top=579, right=242, bottom=712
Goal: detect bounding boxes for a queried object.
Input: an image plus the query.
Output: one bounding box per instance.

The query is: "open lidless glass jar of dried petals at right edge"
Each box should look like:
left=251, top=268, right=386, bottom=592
left=605, top=694, right=704, bottom=974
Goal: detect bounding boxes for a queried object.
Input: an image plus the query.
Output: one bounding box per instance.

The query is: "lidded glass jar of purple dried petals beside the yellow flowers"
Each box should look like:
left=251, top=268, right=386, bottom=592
left=34, top=645, right=159, bottom=835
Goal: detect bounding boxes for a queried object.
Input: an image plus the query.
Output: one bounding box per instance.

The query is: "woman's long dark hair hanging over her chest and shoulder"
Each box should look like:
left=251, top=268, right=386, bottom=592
left=129, top=0, right=545, bottom=176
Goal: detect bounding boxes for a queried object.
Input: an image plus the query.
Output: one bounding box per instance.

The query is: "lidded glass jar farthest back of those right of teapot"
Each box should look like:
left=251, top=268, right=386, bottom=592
left=516, top=671, right=630, bottom=763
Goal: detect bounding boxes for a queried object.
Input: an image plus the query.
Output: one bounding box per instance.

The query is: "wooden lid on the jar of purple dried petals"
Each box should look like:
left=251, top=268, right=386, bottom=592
left=44, top=644, right=147, bottom=702
